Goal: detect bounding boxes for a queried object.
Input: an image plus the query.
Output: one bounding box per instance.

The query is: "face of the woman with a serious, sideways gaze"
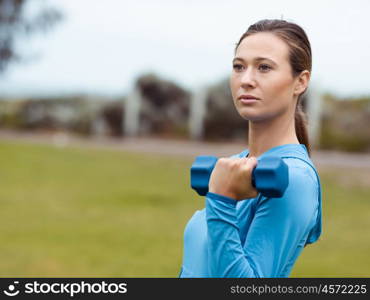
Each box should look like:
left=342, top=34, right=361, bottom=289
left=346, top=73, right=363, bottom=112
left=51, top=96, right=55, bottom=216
left=230, top=32, right=296, bottom=121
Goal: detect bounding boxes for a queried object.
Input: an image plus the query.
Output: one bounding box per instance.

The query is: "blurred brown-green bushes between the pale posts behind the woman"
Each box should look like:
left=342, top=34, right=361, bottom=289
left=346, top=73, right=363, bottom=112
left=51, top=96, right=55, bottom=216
left=0, top=74, right=370, bottom=151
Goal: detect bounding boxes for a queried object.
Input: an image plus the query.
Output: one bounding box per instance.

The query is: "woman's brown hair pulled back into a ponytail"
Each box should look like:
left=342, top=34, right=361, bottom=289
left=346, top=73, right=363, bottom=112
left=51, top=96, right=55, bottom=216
left=235, top=19, right=312, bottom=155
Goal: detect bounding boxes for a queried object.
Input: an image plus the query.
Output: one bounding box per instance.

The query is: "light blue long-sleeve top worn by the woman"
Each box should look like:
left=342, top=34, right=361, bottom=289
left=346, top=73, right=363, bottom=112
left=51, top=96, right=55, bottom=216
left=179, top=144, right=322, bottom=278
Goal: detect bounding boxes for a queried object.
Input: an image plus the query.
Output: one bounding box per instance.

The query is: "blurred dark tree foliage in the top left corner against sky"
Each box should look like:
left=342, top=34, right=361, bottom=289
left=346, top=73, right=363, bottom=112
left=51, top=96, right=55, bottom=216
left=0, top=0, right=62, bottom=75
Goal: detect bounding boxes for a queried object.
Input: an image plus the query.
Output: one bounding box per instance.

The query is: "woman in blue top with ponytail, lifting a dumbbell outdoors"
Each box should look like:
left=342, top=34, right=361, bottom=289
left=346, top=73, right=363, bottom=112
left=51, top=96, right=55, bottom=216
left=179, top=20, right=321, bottom=277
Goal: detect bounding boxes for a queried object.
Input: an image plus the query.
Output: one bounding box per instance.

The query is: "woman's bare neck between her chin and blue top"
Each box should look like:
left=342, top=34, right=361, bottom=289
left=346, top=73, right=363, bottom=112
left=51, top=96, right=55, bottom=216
left=248, top=111, right=299, bottom=157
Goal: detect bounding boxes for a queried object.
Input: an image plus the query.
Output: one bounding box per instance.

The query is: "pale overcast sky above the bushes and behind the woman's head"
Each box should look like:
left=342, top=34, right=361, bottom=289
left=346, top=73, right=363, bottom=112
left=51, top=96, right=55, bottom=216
left=0, top=0, right=370, bottom=97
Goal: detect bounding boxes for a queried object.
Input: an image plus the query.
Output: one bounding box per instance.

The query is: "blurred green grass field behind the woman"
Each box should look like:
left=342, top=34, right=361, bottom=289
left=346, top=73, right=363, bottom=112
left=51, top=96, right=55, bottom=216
left=0, top=141, right=370, bottom=277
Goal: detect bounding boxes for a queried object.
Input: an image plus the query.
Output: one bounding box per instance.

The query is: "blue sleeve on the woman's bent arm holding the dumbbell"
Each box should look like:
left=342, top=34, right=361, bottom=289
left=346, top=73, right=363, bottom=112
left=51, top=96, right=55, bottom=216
left=206, top=165, right=318, bottom=278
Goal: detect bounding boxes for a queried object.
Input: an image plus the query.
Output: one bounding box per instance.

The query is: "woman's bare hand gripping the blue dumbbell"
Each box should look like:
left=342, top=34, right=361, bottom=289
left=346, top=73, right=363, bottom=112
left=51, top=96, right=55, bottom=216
left=208, top=156, right=258, bottom=200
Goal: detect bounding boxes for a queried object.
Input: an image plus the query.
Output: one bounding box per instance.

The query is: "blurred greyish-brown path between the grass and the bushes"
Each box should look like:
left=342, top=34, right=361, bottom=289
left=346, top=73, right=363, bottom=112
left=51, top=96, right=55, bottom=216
left=0, top=130, right=370, bottom=170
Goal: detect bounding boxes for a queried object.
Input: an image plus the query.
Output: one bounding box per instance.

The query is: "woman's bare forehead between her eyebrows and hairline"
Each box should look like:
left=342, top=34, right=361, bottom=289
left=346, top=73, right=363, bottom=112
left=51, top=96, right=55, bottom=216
left=235, top=32, right=289, bottom=62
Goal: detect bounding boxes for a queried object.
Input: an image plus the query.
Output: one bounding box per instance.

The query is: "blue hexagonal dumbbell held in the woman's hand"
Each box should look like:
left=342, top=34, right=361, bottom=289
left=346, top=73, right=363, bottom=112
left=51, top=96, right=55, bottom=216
left=190, top=156, right=289, bottom=197
